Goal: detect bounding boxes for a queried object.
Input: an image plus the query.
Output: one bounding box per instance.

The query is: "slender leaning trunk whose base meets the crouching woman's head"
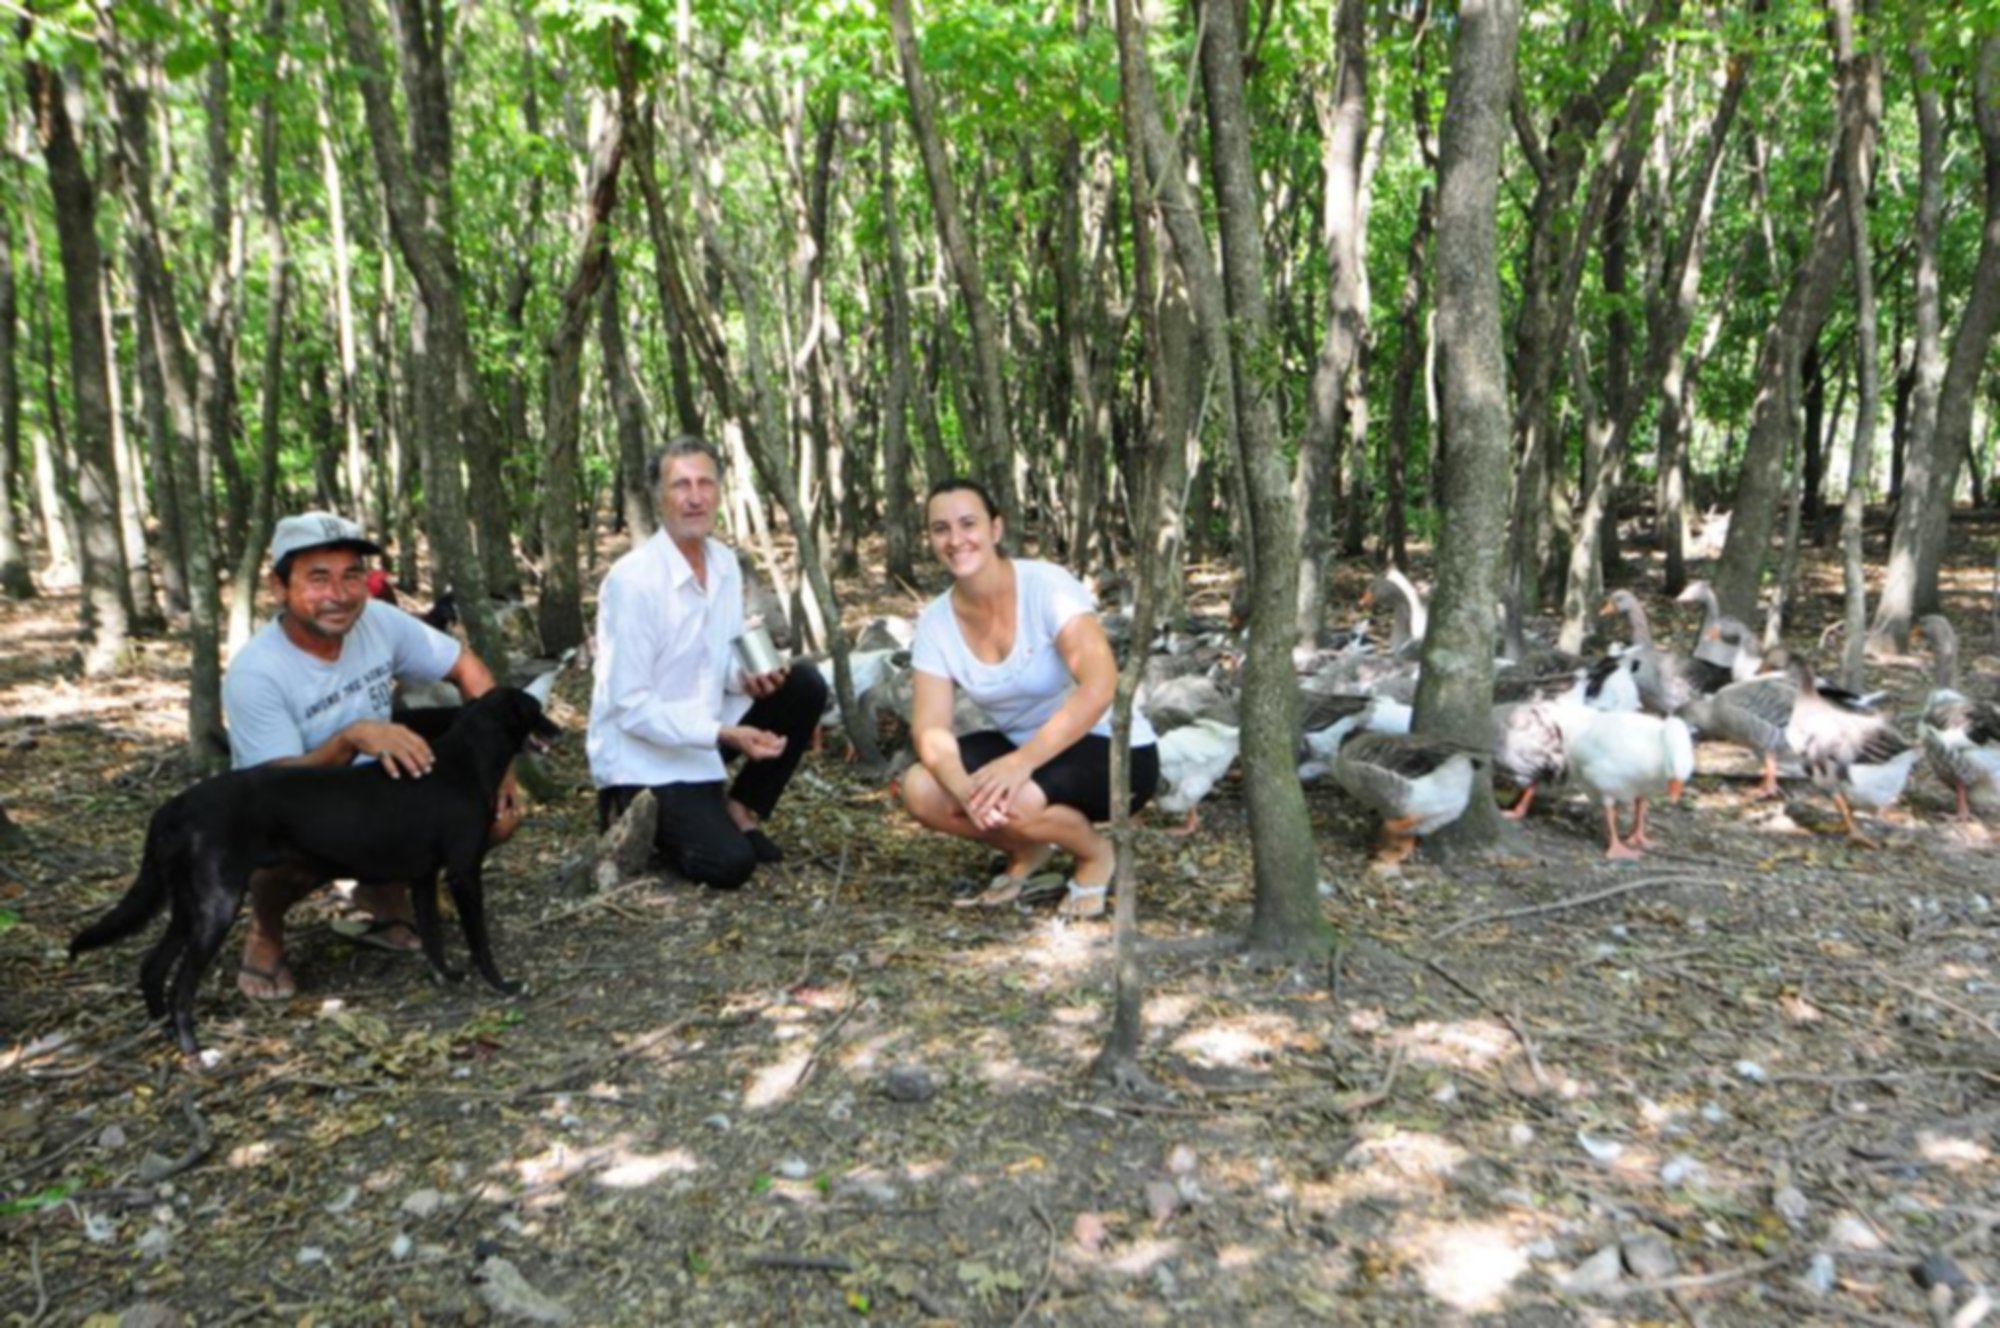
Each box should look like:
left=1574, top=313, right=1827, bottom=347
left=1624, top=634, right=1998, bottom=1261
left=888, top=0, right=1026, bottom=532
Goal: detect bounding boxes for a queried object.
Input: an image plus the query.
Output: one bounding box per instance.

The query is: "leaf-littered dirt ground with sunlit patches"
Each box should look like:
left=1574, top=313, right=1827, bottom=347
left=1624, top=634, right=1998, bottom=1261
left=0, top=526, right=2000, bottom=1324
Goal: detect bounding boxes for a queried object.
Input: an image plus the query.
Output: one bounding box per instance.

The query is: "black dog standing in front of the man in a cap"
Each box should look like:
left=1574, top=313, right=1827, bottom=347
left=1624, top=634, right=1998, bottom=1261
left=70, top=688, right=560, bottom=1054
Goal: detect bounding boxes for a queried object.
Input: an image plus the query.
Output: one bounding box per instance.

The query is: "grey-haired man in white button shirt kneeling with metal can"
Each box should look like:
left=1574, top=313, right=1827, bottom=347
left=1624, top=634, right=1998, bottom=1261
left=588, top=438, right=826, bottom=890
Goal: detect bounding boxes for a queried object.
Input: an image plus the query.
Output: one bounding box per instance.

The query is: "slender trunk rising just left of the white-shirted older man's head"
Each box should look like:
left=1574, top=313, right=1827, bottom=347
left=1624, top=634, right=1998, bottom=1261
left=538, top=88, right=624, bottom=654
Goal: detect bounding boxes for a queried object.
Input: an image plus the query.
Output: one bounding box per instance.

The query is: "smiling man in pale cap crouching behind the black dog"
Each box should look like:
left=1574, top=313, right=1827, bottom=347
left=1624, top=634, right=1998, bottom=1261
left=222, top=512, right=520, bottom=1000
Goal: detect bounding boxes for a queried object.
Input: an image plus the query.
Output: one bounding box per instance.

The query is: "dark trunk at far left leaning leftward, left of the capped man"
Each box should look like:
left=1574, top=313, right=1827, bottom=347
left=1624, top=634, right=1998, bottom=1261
left=24, top=49, right=132, bottom=678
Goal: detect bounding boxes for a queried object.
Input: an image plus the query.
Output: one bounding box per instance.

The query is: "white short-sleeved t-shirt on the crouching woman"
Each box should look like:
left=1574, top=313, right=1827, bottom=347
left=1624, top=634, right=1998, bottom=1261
left=910, top=558, right=1154, bottom=746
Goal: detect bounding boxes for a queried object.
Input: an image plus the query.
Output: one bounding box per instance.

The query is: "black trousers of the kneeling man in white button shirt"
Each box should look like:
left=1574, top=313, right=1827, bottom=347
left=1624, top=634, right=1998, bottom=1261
left=598, top=664, right=826, bottom=890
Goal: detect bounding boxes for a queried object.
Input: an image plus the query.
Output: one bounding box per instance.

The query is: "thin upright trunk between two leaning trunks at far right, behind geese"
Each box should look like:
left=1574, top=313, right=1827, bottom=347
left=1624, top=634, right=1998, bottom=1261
left=1828, top=0, right=1882, bottom=694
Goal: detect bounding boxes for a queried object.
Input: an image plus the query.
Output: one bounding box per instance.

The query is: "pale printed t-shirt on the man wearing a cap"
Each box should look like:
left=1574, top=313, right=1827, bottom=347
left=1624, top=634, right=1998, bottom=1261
left=222, top=600, right=460, bottom=770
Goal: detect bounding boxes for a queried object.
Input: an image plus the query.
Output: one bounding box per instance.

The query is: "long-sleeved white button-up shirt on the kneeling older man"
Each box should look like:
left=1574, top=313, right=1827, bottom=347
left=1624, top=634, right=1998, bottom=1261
left=586, top=530, right=750, bottom=788
